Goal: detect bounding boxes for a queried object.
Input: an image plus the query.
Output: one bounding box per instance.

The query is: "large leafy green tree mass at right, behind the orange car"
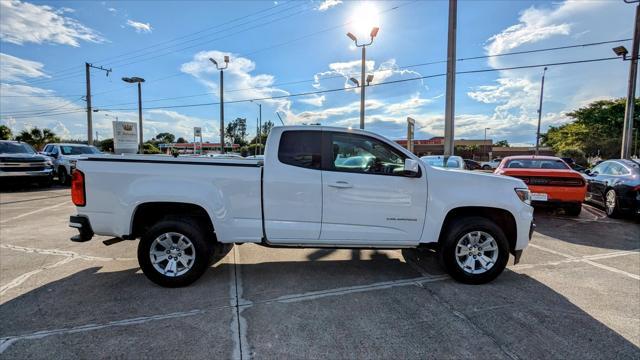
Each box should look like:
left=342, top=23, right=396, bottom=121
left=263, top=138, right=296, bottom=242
left=542, top=99, right=640, bottom=159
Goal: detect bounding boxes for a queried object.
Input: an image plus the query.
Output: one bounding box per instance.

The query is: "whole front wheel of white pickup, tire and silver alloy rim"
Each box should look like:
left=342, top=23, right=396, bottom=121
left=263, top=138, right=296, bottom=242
left=440, top=216, right=509, bottom=284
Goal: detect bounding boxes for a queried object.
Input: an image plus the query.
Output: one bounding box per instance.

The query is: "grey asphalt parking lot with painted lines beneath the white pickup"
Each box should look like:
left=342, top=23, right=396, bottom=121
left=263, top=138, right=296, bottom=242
left=0, top=187, right=640, bottom=359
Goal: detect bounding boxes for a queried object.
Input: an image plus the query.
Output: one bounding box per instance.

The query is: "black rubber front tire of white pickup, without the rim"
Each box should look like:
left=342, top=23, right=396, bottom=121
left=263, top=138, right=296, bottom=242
left=439, top=216, right=509, bottom=285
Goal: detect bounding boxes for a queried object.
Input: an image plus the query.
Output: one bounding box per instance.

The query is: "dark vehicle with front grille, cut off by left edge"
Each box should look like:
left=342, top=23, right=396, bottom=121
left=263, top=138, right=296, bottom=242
left=0, top=140, right=53, bottom=186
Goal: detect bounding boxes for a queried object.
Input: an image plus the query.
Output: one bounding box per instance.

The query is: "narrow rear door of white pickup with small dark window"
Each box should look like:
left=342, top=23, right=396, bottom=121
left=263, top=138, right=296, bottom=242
left=263, top=129, right=322, bottom=244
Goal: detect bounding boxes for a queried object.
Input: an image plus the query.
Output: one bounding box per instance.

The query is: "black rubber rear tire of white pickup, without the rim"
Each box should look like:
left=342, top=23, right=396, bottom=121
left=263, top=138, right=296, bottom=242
left=138, top=218, right=214, bottom=287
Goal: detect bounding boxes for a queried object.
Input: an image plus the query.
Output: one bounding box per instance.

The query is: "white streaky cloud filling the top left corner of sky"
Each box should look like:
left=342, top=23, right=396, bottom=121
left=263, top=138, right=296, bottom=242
left=0, top=0, right=105, bottom=47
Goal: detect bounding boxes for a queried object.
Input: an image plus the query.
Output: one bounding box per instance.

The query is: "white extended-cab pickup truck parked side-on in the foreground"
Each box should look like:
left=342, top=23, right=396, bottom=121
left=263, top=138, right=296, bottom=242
left=69, top=126, right=533, bottom=287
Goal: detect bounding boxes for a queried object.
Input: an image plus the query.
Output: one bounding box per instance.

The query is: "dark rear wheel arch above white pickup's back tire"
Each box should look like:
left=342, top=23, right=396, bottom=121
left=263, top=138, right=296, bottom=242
left=129, top=201, right=215, bottom=239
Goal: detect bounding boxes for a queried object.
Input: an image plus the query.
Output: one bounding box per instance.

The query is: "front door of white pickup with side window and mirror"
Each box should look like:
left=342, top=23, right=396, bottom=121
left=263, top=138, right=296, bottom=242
left=320, top=131, right=427, bottom=246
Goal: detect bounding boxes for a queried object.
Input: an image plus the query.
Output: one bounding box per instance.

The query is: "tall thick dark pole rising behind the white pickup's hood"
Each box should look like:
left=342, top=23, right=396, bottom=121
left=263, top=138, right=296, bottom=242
left=444, top=0, right=458, bottom=157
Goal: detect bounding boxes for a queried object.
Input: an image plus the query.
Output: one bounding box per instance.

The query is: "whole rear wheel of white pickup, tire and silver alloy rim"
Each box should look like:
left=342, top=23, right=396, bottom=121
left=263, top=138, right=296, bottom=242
left=138, top=219, right=213, bottom=287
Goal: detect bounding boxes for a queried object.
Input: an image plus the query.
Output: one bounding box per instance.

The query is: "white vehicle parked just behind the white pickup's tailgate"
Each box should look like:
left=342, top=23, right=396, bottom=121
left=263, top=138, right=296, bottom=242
left=42, top=144, right=101, bottom=185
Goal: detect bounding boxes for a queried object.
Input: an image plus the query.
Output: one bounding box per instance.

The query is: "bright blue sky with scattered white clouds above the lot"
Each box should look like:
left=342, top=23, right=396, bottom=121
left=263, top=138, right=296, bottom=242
left=0, top=0, right=634, bottom=144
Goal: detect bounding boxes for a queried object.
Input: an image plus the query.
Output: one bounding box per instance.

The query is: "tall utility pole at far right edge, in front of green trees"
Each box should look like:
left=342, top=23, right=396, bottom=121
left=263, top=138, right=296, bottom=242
left=620, top=0, right=640, bottom=159
